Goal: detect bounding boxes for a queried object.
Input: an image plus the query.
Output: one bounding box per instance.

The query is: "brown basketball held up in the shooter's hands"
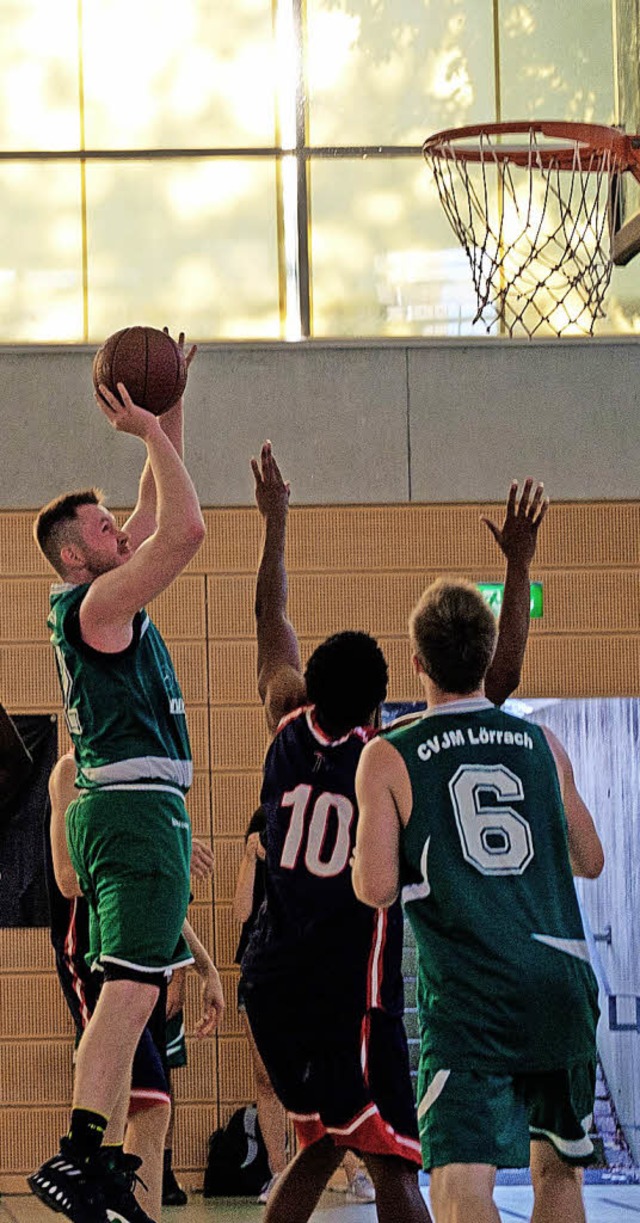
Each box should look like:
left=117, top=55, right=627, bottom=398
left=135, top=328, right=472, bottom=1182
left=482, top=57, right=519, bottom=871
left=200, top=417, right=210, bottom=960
left=93, top=327, right=187, bottom=416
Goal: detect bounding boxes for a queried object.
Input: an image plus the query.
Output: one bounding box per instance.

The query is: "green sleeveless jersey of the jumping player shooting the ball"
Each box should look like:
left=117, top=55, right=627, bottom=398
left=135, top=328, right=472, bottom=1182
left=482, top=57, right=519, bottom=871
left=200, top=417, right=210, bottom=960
left=48, top=583, right=193, bottom=794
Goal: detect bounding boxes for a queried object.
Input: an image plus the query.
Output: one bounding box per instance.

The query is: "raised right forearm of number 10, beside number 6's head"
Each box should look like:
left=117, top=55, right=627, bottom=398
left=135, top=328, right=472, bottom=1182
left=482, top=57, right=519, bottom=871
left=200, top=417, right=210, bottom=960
left=485, top=560, right=531, bottom=704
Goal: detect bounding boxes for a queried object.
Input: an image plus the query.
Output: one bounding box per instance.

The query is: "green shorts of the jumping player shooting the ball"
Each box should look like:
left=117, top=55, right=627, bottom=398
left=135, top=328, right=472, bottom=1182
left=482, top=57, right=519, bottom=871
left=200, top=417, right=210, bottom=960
left=66, top=790, right=192, bottom=974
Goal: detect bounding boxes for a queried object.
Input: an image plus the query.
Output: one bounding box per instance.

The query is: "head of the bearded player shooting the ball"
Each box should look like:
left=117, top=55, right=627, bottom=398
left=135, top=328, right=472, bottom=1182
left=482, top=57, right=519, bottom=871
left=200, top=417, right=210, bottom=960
left=33, top=488, right=131, bottom=581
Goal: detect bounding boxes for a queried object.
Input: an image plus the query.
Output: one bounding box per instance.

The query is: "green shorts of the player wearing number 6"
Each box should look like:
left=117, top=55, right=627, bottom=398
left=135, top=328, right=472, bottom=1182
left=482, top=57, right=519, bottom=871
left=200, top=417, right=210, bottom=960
left=417, top=1060, right=596, bottom=1172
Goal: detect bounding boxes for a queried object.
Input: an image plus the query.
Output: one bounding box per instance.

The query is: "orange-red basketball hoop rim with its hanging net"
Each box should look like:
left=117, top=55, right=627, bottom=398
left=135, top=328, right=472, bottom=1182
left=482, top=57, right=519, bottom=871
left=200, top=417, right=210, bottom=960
left=422, top=121, right=640, bottom=338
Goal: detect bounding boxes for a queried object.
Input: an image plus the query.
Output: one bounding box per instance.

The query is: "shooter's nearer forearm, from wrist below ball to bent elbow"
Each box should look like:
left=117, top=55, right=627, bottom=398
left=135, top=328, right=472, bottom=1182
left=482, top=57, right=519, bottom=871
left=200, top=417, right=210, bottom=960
left=146, top=428, right=204, bottom=543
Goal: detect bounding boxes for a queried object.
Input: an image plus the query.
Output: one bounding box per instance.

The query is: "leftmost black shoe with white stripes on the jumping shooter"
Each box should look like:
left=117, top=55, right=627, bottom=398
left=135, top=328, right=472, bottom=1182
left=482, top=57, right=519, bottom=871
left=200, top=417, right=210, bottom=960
left=27, top=1139, right=110, bottom=1223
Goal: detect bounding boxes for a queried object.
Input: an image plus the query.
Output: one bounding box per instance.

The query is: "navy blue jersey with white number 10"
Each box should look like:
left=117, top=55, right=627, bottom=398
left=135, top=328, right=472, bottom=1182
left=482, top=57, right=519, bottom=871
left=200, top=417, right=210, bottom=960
left=242, top=708, right=403, bottom=1014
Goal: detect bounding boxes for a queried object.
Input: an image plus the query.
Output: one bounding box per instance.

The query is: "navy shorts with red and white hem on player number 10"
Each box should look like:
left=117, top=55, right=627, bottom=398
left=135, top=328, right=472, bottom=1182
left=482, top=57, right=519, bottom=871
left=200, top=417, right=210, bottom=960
left=242, top=980, right=421, bottom=1166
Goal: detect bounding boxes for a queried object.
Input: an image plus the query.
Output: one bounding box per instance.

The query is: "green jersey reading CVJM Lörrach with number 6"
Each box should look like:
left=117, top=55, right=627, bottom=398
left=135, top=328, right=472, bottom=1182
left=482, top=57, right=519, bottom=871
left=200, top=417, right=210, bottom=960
left=385, top=698, right=597, bottom=1074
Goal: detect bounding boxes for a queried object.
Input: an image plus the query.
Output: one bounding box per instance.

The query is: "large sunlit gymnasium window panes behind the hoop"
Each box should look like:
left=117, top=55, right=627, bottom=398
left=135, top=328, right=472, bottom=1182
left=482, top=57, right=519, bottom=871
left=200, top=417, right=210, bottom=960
left=0, top=0, right=640, bottom=342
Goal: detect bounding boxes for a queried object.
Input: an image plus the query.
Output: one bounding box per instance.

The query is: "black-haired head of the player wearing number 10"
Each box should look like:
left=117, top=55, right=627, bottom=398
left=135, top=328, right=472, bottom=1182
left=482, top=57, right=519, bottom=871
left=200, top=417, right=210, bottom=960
left=305, top=632, right=389, bottom=737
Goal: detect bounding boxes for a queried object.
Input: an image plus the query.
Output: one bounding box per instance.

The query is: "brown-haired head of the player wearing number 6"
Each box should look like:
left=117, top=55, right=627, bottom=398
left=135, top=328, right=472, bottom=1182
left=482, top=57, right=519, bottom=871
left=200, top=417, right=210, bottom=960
left=409, top=577, right=496, bottom=695
